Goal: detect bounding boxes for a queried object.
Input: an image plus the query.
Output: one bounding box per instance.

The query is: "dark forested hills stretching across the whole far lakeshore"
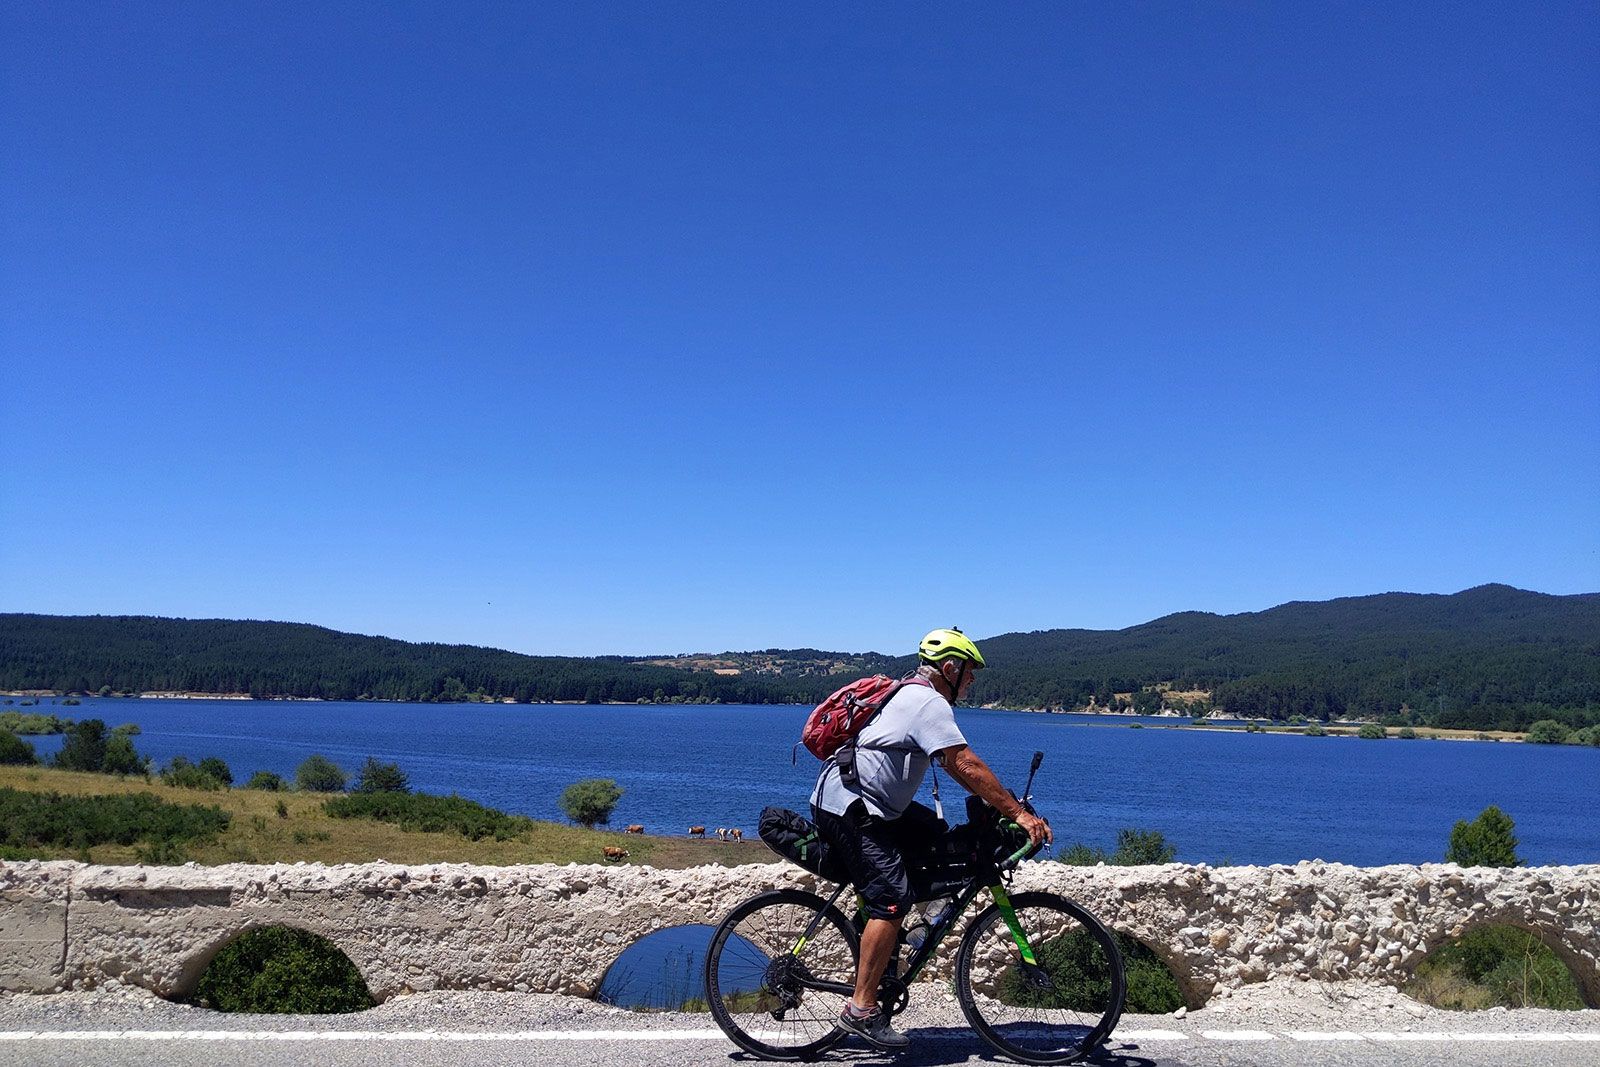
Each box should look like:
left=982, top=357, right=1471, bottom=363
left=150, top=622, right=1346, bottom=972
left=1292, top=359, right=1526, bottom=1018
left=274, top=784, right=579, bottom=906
left=0, top=585, right=1600, bottom=729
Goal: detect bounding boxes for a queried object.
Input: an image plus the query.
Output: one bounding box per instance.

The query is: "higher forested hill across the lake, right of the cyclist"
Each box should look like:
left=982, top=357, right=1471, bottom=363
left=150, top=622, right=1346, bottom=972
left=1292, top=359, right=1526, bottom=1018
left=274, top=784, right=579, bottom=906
left=973, top=585, right=1600, bottom=729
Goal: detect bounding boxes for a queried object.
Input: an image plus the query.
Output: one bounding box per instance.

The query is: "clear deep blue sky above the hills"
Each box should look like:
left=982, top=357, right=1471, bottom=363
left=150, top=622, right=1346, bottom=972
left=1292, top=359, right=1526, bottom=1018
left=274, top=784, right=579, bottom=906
left=0, top=0, right=1600, bottom=654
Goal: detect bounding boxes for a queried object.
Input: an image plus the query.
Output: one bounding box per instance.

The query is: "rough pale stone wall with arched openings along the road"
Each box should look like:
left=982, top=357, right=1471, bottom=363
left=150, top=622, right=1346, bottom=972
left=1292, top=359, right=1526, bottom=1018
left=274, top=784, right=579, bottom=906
left=0, top=862, right=1600, bottom=1008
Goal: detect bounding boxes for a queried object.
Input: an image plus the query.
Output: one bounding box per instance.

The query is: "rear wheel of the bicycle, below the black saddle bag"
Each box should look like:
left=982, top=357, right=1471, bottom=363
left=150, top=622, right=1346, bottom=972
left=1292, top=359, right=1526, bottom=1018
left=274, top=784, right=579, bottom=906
left=706, top=889, right=861, bottom=1059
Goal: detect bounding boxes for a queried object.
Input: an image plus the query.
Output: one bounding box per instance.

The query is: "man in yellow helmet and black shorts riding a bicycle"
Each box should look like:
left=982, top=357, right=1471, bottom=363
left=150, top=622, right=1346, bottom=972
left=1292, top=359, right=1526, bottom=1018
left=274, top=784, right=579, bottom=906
left=811, top=629, right=1051, bottom=1049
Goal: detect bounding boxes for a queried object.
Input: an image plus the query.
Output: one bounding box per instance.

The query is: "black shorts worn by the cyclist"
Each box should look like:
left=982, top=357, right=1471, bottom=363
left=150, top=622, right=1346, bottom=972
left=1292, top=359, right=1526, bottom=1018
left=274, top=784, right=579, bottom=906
left=811, top=800, right=947, bottom=920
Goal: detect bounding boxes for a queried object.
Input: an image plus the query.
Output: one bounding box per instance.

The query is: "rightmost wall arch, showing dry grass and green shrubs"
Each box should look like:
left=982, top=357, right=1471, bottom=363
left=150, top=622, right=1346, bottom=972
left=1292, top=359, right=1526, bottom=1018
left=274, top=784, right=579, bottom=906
left=1402, top=926, right=1584, bottom=1011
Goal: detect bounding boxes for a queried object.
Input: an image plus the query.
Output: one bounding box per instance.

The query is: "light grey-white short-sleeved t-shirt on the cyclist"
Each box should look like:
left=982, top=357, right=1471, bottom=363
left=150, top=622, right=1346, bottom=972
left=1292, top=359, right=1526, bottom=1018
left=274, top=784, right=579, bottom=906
left=811, top=683, right=966, bottom=819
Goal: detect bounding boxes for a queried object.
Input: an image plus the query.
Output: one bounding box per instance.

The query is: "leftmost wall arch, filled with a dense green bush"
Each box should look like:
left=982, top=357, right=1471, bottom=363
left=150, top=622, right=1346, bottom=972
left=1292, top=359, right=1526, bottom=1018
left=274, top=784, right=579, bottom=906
left=186, top=926, right=374, bottom=1014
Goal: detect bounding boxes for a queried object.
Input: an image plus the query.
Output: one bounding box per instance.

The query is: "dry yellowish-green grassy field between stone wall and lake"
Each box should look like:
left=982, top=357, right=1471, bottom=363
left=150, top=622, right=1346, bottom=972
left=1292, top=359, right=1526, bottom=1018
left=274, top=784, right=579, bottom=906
left=0, top=766, right=776, bottom=869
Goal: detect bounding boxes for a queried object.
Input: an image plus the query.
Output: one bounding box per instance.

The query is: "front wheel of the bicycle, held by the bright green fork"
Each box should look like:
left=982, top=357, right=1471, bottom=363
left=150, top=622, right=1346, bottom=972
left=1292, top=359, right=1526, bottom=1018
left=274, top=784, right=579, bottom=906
left=955, top=893, right=1128, bottom=1064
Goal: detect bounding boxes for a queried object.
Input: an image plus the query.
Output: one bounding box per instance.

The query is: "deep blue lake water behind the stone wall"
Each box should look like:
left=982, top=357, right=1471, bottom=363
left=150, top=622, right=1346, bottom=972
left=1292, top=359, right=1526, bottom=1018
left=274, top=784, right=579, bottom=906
left=11, top=697, right=1600, bottom=865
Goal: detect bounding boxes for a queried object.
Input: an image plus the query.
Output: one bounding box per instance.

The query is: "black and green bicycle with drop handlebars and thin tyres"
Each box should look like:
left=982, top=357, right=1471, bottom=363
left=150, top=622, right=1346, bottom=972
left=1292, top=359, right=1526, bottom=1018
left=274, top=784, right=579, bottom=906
left=706, top=752, right=1126, bottom=1064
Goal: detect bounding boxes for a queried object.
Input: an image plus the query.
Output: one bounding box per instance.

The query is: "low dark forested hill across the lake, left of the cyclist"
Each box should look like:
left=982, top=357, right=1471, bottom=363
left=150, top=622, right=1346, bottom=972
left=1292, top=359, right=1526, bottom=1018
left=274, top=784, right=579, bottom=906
left=0, top=614, right=819, bottom=704
